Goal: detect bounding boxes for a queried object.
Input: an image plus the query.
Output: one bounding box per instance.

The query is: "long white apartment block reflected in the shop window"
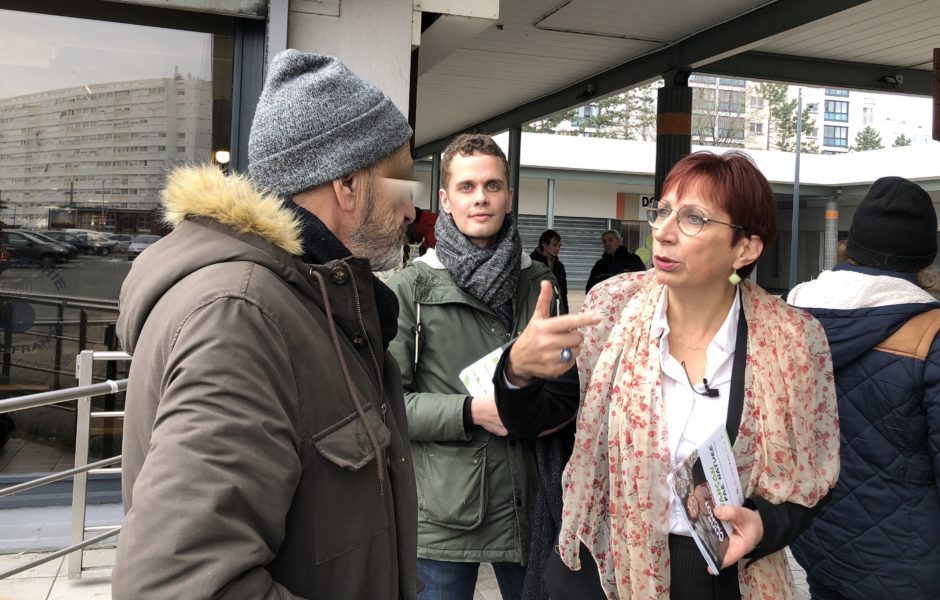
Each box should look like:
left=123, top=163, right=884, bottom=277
left=0, top=75, right=212, bottom=229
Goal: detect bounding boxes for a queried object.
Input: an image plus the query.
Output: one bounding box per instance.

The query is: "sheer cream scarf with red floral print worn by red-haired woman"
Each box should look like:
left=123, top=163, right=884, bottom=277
left=559, top=271, right=839, bottom=600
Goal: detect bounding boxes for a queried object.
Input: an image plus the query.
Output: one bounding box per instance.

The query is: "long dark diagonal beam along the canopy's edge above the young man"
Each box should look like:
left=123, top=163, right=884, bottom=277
left=414, top=0, right=869, bottom=157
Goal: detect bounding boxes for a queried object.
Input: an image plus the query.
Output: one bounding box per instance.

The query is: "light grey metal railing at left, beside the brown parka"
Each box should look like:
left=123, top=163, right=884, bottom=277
left=0, top=350, right=131, bottom=579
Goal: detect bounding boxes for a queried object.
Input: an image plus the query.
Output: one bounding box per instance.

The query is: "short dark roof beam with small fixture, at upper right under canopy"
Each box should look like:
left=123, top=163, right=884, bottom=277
left=702, top=52, right=933, bottom=96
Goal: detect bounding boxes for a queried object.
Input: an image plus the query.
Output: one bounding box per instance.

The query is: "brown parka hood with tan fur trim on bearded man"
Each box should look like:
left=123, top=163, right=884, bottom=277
left=118, top=166, right=313, bottom=353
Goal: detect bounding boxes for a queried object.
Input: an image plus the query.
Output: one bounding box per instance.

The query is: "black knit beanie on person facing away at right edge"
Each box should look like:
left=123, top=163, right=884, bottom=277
left=845, top=177, right=937, bottom=273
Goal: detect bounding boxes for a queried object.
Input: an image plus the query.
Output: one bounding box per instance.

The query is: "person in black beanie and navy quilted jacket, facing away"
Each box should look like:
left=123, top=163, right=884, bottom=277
left=788, top=177, right=940, bottom=599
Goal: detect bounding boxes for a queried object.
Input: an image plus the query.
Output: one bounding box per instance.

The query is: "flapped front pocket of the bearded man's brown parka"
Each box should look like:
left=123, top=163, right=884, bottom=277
left=312, top=404, right=392, bottom=564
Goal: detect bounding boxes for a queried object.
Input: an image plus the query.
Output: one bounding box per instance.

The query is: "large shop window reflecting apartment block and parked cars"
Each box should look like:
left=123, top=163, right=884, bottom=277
left=0, top=5, right=234, bottom=473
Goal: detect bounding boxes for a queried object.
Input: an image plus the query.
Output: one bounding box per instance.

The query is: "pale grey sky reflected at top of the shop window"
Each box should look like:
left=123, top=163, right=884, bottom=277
left=0, top=10, right=212, bottom=98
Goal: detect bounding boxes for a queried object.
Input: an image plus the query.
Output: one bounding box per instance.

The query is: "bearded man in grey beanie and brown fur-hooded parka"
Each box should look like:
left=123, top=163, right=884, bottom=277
left=112, top=50, right=418, bottom=600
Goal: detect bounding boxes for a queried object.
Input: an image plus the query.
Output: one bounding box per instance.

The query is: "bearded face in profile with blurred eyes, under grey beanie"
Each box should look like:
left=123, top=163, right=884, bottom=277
left=348, top=144, right=415, bottom=271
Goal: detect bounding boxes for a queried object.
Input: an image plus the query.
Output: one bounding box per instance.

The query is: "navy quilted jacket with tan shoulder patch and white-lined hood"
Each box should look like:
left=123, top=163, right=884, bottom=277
left=788, top=265, right=940, bottom=600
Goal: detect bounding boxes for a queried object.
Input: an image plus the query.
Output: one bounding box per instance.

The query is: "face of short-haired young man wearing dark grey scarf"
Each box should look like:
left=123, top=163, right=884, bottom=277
left=439, top=153, right=512, bottom=248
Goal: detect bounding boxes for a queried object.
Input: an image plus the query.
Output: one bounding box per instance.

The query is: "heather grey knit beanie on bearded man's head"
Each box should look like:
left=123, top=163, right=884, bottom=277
left=248, top=50, right=411, bottom=199
